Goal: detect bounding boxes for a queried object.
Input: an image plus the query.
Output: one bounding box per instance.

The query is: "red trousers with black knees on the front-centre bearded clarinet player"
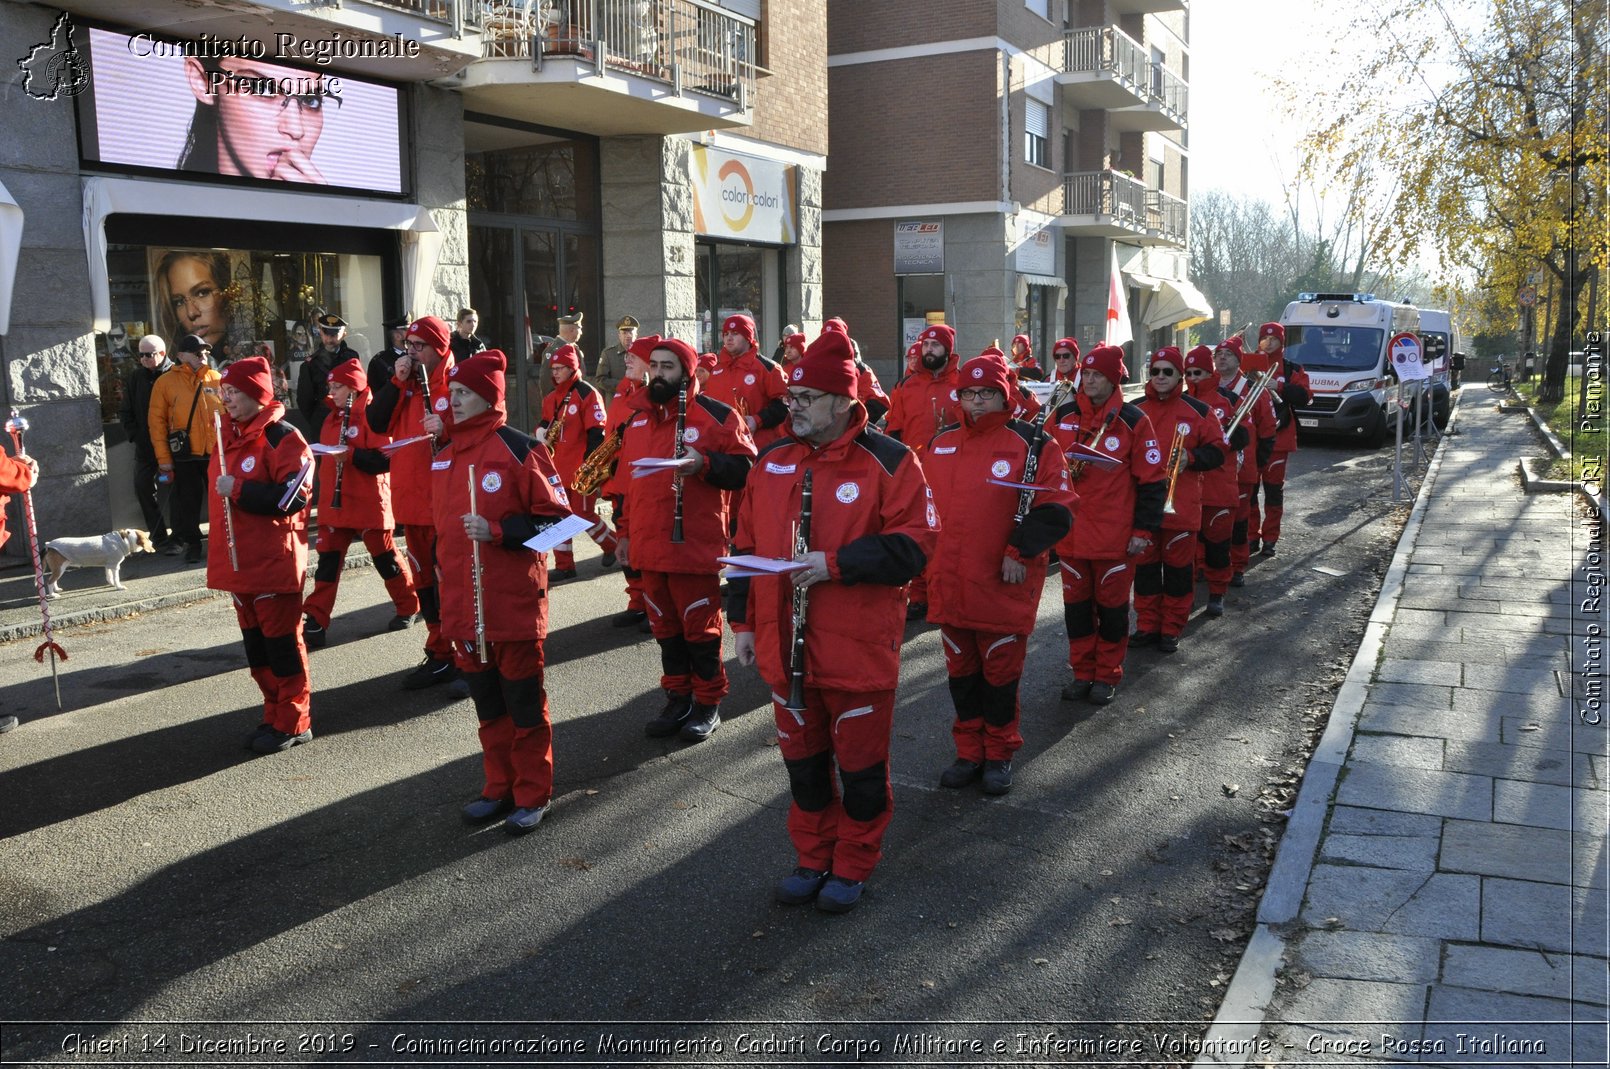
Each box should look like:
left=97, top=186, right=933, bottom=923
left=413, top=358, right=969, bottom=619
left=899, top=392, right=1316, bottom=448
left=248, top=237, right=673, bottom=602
left=771, top=686, right=895, bottom=881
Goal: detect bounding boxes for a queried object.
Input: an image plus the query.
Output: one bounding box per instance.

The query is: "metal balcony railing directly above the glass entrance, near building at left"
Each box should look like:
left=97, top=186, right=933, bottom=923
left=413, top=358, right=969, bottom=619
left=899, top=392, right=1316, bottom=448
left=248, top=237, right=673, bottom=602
left=476, top=0, right=755, bottom=105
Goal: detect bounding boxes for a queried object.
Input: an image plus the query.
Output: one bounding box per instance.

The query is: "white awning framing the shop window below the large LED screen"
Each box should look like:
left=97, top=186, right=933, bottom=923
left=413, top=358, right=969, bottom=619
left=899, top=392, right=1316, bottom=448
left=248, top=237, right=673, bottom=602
left=81, top=177, right=441, bottom=333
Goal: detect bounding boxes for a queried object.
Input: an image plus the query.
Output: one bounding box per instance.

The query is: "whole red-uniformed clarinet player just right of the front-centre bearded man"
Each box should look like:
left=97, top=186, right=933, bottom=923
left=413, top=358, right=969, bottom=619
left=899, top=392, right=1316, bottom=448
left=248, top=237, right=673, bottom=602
left=924, top=349, right=1077, bottom=794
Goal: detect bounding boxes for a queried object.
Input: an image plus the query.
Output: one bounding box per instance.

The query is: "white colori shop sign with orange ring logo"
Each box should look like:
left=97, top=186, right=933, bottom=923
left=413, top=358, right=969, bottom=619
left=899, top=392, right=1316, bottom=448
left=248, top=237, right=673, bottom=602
left=689, top=145, right=799, bottom=245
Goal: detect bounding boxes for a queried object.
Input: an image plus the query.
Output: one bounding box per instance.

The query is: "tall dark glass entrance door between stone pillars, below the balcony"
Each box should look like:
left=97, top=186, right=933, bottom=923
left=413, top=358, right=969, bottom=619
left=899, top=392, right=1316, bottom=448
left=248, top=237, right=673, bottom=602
left=470, top=216, right=599, bottom=433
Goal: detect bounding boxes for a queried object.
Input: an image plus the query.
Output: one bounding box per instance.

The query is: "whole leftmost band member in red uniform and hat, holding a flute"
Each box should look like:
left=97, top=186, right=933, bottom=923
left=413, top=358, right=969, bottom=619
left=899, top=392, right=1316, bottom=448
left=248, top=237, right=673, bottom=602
left=206, top=356, right=312, bottom=753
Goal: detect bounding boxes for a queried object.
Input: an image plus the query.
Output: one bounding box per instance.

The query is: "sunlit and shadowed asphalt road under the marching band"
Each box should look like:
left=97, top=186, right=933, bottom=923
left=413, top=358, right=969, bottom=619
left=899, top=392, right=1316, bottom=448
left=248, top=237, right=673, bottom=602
left=0, top=431, right=1407, bottom=1064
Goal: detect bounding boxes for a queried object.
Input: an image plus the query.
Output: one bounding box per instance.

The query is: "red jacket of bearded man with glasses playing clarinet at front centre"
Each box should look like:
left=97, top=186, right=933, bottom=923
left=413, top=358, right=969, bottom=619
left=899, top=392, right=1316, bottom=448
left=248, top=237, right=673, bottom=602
left=727, top=407, right=939, bottom=694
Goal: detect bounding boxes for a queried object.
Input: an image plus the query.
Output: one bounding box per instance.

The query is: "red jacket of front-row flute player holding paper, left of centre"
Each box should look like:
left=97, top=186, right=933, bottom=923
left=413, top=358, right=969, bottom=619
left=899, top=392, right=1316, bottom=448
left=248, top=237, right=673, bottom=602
left=430, top=409, right=570, bottom=642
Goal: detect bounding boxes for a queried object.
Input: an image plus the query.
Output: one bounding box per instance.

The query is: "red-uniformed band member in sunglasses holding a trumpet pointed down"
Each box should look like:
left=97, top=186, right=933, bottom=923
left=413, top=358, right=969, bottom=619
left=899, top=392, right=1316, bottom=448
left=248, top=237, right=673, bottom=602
left=1129, top=345, right=1228, bottom=654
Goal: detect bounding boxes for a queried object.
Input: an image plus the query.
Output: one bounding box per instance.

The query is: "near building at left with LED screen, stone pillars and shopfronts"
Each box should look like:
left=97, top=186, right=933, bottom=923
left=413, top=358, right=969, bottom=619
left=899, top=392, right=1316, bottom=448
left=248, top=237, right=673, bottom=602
left=0, top=0, right=828, bottom=534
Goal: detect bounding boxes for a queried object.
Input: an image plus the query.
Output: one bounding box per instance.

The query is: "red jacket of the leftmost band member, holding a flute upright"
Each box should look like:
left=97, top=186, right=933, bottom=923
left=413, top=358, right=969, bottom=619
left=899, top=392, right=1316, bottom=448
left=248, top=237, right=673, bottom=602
left=206, top=401, right=312, bottom=594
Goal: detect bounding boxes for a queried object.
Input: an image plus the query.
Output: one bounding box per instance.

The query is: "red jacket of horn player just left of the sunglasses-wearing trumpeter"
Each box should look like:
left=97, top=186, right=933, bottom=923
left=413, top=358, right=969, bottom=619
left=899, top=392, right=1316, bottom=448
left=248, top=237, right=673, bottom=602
left=1048, top=390, right=1166, bottom=560
